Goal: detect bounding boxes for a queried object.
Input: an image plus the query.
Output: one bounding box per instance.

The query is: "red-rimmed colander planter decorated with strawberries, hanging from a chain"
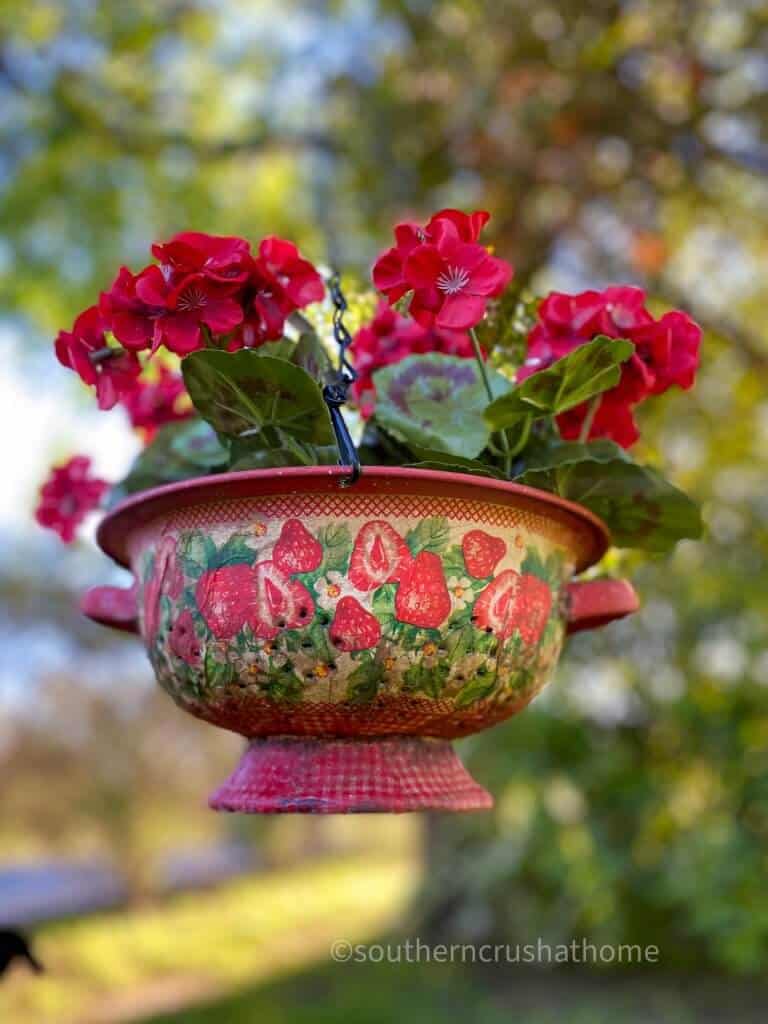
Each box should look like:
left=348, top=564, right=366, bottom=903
left=83, top=466, right=637, bottom=813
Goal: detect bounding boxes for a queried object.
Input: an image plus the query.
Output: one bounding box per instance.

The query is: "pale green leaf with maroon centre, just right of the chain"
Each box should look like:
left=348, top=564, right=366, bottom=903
left=374, top=352, right=509, bottom=459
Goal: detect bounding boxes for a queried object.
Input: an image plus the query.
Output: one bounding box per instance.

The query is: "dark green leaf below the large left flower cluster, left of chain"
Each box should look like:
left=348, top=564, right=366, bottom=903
left=181, top=349, right=334, bottom=449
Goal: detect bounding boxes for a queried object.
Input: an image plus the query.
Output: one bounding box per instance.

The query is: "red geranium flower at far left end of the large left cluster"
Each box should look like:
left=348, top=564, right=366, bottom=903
left=54, top=306, right=141, bottom=409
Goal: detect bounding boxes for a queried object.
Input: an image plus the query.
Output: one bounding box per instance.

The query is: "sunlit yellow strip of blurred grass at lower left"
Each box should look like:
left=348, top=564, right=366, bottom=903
left=0, top=854, right=418, bottom=1024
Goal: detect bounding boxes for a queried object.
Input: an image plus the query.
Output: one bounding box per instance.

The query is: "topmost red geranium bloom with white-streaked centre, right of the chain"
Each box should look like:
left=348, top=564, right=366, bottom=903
left=373, top=210, right=513, bottom=331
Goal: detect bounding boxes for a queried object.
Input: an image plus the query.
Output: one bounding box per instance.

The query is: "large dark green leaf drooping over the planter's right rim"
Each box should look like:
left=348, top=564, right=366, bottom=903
left=519, top=456, right=701, bottom=553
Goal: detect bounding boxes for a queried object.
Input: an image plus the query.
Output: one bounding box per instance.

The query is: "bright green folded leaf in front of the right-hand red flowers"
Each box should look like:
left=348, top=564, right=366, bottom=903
left=484, top=335, right=635, bottom=430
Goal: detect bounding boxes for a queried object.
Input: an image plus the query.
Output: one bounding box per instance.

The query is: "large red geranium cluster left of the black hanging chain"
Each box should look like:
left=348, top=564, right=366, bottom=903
left=55, top=231, right=325, bottom=409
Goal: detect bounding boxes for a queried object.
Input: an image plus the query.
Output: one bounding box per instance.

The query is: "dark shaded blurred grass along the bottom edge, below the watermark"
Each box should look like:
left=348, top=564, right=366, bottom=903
left=144, top=958, right=766, bottom=1024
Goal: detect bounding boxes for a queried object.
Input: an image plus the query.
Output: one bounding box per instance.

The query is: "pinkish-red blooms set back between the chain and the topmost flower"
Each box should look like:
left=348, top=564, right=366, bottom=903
left=349, top=300, right=474, bottom=419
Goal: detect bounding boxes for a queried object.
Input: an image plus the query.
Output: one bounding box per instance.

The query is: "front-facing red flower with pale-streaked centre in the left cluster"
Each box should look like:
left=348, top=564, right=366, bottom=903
left=136, top=266, right=243, bottom=355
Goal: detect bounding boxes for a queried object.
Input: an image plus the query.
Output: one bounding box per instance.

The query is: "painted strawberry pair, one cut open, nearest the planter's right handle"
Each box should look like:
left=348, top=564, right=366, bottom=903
left=473, top=569, right=552, bottom=644
